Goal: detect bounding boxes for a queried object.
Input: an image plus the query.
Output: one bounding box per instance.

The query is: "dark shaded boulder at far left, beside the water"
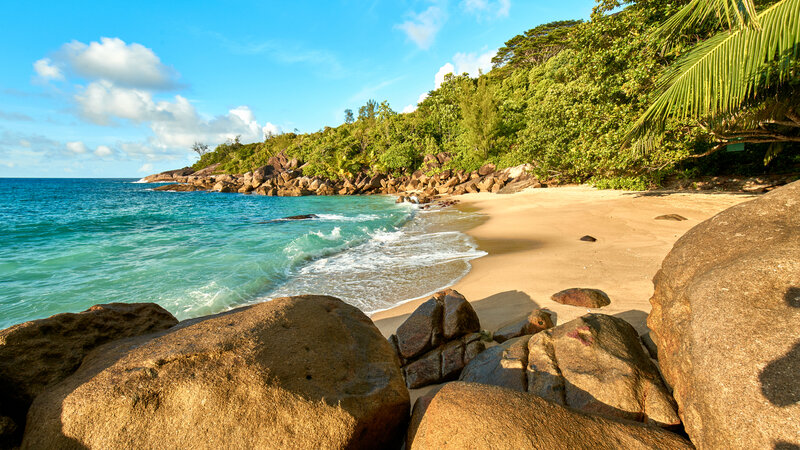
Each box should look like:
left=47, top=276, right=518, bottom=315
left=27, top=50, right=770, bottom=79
left=0, top=303, right=178, bottom=442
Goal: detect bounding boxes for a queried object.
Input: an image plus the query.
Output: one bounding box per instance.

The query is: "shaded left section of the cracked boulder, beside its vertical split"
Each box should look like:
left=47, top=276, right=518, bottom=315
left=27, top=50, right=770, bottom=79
left=458, top=336, right=530, bottom=392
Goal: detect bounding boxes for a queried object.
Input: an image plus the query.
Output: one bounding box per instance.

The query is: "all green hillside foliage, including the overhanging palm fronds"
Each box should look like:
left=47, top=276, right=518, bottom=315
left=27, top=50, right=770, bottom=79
left=195, top=0, right=800, bottom=189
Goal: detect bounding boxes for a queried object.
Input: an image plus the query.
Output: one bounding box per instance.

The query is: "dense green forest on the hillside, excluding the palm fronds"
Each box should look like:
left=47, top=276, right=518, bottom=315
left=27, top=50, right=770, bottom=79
left=194, top=0, right=800, bottom=189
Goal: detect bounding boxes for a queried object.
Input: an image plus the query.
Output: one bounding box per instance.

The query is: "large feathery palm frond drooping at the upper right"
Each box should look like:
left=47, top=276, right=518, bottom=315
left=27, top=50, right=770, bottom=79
left=626, top=0, right=800, bottom=151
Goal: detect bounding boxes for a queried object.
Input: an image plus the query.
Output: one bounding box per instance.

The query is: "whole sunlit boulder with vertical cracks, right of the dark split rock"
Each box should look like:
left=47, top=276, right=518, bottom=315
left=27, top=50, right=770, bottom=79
left=460, top=314, right=680, bottom=427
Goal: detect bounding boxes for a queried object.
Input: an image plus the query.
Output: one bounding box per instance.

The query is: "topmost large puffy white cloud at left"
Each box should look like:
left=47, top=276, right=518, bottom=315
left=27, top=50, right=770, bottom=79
left=54, top=37, right=177, bottom=89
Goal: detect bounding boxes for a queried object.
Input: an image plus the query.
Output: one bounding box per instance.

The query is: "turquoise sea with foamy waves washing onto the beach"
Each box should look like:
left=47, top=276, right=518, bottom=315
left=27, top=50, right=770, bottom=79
left=0, top=179, right=482, bottom=329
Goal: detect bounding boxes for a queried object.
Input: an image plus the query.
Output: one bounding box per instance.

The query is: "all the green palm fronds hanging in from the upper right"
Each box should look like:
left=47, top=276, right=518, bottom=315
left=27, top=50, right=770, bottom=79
left=627, top=0, right=800, bottom=150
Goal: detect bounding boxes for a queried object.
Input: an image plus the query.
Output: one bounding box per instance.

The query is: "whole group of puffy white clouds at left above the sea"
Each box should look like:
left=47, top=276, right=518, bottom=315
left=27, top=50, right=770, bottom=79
left=34, top=38, right=281, bottom=161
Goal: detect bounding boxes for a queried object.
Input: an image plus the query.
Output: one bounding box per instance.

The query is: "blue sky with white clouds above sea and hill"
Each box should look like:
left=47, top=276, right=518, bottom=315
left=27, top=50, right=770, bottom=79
left=0, top=0, right=595, bottom=178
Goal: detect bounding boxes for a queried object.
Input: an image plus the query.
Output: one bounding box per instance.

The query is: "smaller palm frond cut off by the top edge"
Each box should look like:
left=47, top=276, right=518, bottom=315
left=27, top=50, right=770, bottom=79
left=655, top=0, right=760, bottom=42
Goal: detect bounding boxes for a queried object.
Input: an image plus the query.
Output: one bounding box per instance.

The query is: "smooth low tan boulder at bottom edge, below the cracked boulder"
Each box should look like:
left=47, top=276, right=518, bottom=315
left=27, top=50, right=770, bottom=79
left=408, top=383, right=692, bottom=450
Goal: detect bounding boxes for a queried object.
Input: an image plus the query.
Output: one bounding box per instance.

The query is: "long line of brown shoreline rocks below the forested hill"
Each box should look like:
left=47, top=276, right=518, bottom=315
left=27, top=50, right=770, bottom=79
left=144, top=153, right=545, bottom=203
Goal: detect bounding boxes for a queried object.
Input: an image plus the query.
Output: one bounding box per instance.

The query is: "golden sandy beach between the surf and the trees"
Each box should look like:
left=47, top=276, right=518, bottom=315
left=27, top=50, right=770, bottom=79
left=372, top=186, right=755, bottom=336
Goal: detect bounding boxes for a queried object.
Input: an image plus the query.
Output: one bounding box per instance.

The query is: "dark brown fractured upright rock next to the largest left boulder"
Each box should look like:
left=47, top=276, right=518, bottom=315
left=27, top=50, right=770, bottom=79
left=389, top=289, right=485, bottom=389
